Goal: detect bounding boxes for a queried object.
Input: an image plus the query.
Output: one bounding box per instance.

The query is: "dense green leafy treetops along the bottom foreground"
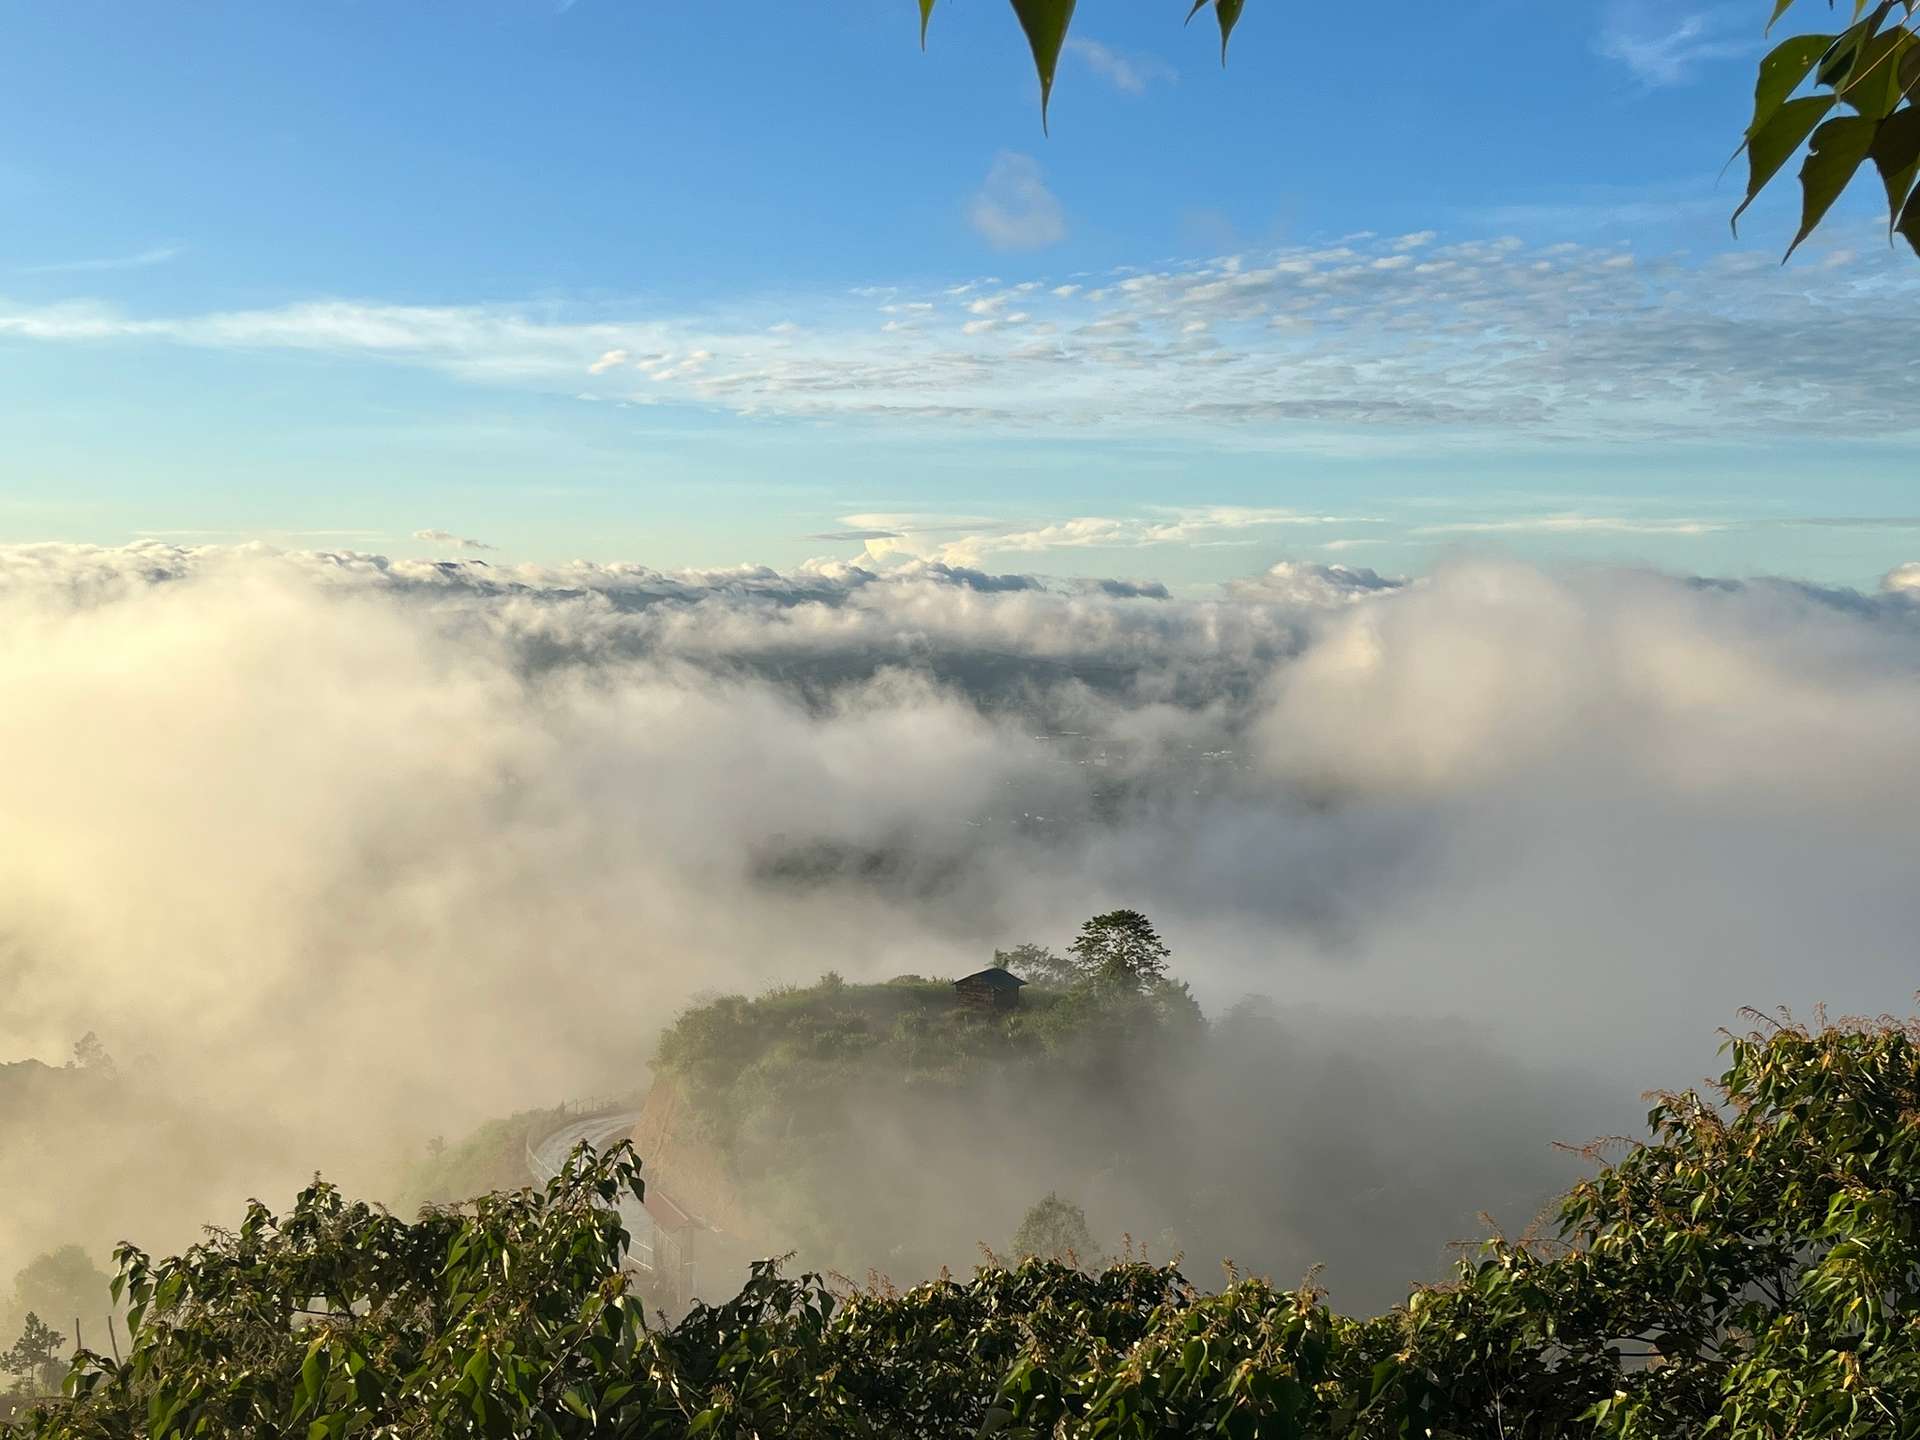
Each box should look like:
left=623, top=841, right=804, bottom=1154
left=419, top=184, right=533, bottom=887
left=21, top=1023, right=1920, bottom=1440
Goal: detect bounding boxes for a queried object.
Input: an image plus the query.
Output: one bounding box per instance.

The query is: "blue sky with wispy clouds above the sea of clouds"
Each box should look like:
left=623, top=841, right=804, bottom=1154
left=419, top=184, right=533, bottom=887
left=0, top=0, right=1920, bottom=586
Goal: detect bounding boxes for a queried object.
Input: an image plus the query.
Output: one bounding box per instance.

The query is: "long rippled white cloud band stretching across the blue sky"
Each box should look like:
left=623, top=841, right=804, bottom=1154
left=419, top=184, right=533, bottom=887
left=0, top=230, right=1920, bottom=449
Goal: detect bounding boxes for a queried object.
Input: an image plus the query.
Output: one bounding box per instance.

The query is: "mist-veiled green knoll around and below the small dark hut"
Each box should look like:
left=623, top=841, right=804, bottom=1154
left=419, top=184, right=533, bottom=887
left=655, top=912, right=1206, bottom=1281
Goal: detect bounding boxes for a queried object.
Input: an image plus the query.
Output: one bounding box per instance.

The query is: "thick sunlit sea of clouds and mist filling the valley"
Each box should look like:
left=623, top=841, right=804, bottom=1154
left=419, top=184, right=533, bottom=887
left=0, top=543, right=1920, bottom=1282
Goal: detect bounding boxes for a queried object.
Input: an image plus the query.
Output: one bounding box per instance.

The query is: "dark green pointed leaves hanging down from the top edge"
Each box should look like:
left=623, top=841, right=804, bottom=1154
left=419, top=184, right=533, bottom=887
left=920, top=0, right=1920, bottom=257
